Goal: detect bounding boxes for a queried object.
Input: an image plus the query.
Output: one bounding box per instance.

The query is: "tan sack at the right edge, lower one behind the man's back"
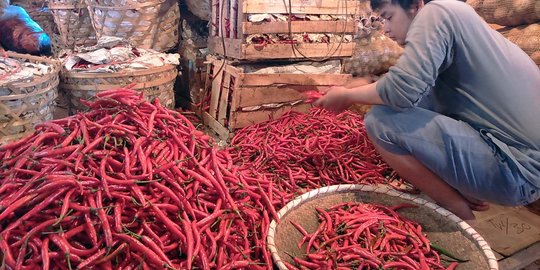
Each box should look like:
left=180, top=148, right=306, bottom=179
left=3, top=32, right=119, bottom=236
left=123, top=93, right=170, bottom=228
left=499, top=23, right=540, bottom=65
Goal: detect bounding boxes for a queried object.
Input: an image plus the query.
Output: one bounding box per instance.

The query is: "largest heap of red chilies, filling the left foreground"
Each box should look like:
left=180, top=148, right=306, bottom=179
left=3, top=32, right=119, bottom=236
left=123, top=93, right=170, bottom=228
left=0, top=89, right=275, bottom=269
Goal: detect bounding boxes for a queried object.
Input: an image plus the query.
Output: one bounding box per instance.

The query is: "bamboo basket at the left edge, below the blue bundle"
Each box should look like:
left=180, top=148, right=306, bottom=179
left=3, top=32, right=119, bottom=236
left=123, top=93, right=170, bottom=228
left=0, top=52, right=60, bottom=144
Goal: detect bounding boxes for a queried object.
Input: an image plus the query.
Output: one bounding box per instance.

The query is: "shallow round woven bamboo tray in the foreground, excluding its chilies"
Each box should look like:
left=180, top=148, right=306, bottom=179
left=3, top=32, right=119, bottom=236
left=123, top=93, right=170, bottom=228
left=267, top=185, right=499, bottom=270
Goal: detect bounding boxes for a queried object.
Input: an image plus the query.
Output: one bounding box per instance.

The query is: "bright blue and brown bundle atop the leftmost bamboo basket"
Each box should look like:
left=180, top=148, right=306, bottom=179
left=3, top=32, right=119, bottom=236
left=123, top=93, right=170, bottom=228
left=0, top=6, right=51, bottom=55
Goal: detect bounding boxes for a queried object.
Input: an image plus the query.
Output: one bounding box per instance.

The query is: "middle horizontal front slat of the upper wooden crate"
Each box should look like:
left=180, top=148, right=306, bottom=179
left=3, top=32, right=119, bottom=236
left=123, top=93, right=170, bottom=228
left=242, top=19, right=356, bottom=35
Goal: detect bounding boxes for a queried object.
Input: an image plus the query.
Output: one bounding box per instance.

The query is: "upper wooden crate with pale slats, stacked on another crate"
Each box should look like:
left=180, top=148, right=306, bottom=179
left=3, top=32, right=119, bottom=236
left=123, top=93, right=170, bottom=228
left=208, top=0, right=369, bottom=60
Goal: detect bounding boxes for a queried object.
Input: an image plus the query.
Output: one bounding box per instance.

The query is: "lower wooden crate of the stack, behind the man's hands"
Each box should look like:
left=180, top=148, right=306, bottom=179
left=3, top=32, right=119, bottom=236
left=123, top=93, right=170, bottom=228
left=200, top=54, right=352, bottom=140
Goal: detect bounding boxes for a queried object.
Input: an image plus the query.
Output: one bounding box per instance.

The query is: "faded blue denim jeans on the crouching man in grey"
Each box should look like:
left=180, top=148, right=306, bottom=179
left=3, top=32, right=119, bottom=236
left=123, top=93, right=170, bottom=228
left=365, top=106, right=540, bottom=206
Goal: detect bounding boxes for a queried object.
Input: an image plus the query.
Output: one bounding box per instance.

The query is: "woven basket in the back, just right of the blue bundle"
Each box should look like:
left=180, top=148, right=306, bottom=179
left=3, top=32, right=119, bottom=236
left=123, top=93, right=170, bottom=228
left=49, top=0, right=96, bottom=49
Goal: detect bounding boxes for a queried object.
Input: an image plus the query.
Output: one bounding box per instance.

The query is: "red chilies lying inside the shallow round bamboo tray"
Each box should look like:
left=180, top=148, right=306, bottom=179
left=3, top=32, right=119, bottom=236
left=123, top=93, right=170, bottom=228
left=286, top=203, right=457, bottom=270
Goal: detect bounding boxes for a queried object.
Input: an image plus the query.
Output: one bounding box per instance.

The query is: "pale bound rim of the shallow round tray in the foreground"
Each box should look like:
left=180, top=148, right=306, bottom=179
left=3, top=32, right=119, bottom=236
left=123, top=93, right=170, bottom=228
left=267, top=184, right=499, bottom=270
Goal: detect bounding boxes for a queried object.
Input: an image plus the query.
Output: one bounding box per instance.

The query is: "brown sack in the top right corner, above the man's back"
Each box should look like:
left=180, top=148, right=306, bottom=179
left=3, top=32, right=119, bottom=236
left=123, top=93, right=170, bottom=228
left=467, top=0, right=540, bottom=26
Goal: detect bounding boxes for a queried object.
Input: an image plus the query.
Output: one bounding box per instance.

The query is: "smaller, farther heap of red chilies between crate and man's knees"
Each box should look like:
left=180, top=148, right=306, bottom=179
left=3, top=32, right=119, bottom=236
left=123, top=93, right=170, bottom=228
left=230, top=108, right=410, bottom=199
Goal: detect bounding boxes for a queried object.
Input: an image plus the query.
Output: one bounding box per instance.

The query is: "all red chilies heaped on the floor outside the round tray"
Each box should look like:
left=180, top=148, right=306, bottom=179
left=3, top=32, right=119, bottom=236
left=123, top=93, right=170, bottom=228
left=0, top=89, right=422, bottom=269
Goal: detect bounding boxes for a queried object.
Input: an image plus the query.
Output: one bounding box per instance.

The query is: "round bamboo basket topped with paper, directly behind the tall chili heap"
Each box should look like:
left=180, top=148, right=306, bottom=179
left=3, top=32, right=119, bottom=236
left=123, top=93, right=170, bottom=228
left=60, top=65, right=178, bottom=114
